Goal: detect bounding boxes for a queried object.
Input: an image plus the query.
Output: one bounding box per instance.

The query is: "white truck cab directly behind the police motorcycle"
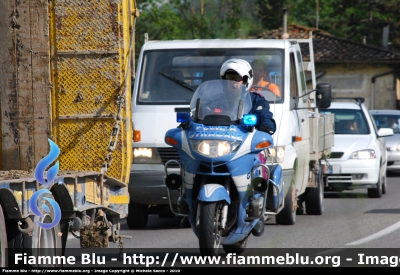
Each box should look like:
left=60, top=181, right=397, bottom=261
left=127, top=36, right=333, bottom=228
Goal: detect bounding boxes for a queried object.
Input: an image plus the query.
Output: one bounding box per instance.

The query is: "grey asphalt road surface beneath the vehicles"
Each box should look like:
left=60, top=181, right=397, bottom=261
left=67, top=175, right=400, bottom=249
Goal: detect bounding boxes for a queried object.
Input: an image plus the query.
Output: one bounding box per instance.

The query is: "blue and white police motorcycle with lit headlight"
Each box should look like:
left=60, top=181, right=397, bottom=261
left=165, top=80, right=284, bottom=256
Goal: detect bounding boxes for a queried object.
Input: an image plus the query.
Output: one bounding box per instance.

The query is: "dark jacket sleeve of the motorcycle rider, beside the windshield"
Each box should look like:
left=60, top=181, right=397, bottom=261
left=249, top=92, right=276, bottom=134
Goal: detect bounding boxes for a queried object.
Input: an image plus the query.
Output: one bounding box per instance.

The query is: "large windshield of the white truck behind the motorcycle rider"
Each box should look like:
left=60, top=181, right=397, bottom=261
left=136, top=49, right=284, bottom=105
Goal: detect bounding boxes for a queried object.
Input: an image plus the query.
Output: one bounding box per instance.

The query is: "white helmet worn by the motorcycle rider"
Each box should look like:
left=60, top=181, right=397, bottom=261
left=219, top=59, right=253, bottom=91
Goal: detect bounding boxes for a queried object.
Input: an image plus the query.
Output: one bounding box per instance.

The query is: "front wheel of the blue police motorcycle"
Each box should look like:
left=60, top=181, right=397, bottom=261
left=199, top=202, right=222, bottom=256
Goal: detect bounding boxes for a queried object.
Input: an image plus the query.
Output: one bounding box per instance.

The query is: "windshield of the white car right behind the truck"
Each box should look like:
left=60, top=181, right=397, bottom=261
left=321, top=109, right=370, bottom=135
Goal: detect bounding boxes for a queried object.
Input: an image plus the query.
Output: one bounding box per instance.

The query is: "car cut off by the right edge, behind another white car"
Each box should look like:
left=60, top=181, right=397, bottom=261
left=369, top=110, right=400, bottom=172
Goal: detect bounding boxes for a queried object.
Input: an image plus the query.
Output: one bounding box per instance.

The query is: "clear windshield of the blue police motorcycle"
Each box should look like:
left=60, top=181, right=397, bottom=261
left=190, top=79, right=252, bottom=126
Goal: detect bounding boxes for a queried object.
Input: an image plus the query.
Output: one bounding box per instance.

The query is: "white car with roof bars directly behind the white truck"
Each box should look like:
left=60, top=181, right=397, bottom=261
left=320, top=98, right=393, bottom=198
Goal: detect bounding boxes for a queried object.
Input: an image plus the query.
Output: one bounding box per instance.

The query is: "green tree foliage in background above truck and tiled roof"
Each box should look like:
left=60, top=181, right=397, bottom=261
left=136, top=0, right=400, bottom=61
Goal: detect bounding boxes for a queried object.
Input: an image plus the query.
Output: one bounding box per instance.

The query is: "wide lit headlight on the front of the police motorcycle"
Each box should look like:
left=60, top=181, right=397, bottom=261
left=190, top=140, right=242, bottom=158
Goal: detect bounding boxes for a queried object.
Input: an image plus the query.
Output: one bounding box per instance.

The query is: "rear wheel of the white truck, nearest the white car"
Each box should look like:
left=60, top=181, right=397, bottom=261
left=304, top=169, right=324, bottom=215
